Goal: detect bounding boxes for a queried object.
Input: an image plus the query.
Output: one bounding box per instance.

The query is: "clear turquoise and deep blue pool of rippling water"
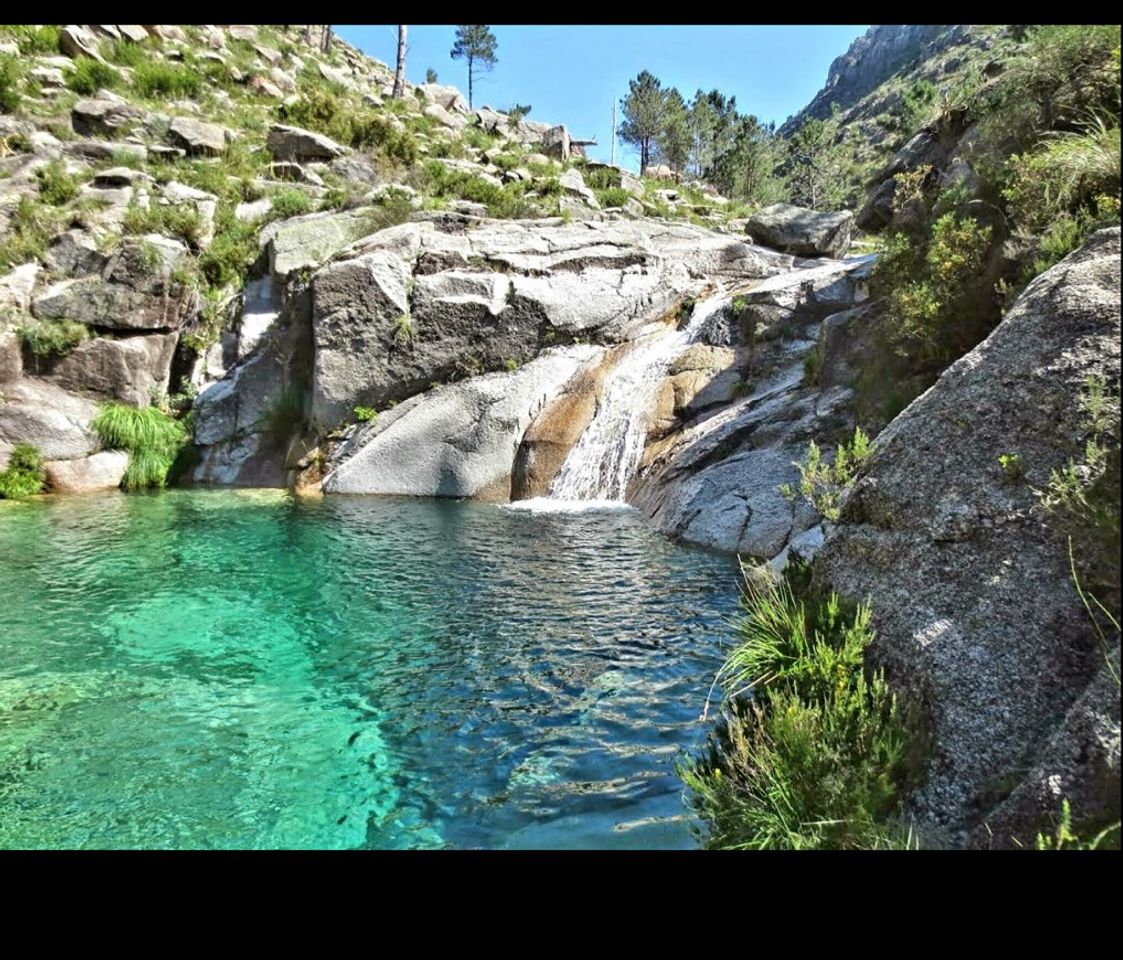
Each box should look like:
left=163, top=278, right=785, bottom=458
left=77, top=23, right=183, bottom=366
left=0, top=491, right=737, bottom=848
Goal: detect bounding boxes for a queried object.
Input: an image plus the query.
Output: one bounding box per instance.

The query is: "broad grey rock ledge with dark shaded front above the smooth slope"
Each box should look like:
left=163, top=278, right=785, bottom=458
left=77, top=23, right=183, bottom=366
left=309, top=221, right=792, bottom=429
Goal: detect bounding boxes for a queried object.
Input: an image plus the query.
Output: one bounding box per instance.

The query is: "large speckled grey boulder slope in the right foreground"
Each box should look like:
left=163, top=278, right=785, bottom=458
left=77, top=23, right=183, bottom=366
left=814, top=228, right=1120, bottom=845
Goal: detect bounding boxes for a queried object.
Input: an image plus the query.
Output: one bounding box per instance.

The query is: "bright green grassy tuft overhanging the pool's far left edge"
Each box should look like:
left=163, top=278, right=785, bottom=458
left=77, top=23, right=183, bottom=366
left=91, top=401, right=189, bottom=491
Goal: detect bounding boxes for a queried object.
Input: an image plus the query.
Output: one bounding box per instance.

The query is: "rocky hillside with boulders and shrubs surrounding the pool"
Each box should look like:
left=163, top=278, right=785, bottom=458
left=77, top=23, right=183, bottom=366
left=0, top=25, right=1120, bottom=845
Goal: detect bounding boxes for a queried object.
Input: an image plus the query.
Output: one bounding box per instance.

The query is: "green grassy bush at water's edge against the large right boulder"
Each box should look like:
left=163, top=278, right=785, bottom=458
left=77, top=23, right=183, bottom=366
left=679, top=563, right=924, bottom=850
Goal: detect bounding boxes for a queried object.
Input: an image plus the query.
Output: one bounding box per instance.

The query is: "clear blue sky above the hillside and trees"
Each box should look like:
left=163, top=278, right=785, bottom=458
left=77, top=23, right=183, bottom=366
left=336, top=25, right=867, bottom=168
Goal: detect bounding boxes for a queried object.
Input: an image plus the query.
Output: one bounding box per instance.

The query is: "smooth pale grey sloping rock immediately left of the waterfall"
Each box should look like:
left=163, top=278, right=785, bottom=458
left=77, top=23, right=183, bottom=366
left=323, top=346, right=602, bottom=501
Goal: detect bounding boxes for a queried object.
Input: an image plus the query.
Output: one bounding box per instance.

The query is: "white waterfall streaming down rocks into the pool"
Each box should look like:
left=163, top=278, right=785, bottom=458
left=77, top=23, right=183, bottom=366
left=549, top=290, right=725, bottom=502
